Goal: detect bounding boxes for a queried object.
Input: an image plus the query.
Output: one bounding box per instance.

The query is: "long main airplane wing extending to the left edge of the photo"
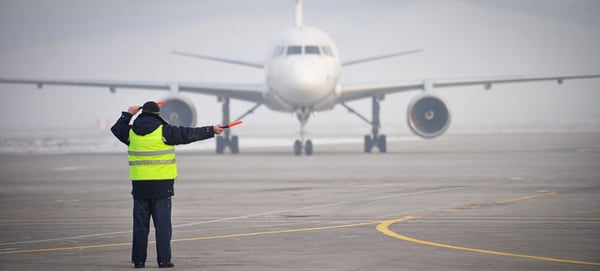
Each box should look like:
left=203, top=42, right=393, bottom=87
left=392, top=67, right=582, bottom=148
left=0, top=78, right=266, bottom=103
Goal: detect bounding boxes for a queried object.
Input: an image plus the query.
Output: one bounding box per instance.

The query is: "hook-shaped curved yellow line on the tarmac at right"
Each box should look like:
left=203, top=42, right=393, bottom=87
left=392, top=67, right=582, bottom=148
left=376, top=192, right=600, bottom=266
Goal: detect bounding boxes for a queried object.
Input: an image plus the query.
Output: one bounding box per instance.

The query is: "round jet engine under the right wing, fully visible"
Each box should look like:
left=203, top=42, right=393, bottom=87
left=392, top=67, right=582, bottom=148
left=406, top=94, right=450, bottom=139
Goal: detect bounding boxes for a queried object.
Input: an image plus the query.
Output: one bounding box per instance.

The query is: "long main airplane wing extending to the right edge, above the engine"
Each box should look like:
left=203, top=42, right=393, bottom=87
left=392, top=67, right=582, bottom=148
left=340, top=74, right=600, bottom=103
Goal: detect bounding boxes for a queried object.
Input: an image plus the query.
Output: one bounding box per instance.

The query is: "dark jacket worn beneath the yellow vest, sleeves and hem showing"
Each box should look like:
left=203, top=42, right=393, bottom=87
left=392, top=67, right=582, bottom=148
left=110, top=112, right=215, bottom=199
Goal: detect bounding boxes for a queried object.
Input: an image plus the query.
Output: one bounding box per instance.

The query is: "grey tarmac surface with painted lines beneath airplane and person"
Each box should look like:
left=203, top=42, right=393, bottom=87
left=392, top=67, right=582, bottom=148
left=0, top=133, right=600, bottom=270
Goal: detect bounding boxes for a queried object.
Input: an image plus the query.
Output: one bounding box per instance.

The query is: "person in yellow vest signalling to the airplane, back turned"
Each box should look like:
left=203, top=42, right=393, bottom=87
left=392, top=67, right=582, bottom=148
left=111, top=102, right=223, bottom=268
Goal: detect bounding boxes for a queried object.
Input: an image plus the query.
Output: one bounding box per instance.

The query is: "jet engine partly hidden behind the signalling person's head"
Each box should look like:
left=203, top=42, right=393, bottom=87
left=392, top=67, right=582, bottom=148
left=160, top=95, right=196, bottom=127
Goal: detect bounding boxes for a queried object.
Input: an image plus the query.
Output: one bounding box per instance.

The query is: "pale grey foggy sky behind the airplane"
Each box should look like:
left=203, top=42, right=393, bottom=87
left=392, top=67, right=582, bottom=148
left=0, top=0, right=600, bottom=135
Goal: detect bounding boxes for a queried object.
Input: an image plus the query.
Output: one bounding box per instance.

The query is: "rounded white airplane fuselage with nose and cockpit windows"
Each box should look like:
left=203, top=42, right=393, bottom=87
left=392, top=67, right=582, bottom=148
left=265, top=27, right=341, bottom=112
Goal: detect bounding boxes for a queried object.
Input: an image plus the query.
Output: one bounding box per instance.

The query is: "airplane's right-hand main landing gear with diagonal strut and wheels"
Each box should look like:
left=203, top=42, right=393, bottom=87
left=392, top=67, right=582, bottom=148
left=342, top=96, right=387, bottom=153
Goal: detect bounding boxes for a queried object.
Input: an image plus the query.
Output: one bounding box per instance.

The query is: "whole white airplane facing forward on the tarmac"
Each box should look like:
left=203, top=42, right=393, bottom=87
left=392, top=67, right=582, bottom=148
left=0, top=0, right=600, bottom=156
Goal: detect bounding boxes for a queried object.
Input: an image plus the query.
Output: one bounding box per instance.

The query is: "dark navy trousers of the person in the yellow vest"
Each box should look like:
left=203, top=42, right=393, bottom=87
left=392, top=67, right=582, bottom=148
left=131, top=197, right=172, bottom=264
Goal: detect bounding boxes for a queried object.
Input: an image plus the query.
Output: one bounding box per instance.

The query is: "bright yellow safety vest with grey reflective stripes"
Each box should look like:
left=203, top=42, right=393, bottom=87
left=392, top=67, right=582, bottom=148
left=127, top=125, right=177, bottom=181
